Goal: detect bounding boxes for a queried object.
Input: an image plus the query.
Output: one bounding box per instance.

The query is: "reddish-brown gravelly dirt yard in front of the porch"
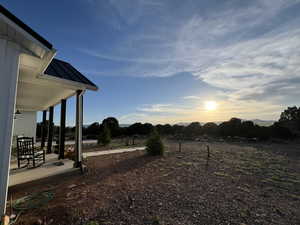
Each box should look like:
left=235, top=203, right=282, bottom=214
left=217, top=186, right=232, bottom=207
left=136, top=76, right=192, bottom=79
left=9, top=142, right=300, bottom=225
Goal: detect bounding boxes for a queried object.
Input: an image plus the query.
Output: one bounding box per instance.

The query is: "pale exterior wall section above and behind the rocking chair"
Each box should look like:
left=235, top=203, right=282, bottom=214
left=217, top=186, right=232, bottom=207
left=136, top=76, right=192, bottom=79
left=13, top=111, right=37, bottom=144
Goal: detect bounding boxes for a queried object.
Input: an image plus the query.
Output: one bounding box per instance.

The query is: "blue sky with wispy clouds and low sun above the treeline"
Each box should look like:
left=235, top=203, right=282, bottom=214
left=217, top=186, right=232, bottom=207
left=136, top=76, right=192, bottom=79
left=0, top=0, right=300, bottom=125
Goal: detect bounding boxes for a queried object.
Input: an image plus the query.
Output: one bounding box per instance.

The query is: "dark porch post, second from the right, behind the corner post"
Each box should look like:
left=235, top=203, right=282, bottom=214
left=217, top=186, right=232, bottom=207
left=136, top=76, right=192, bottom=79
left=58, top=99, right=67, bottom=159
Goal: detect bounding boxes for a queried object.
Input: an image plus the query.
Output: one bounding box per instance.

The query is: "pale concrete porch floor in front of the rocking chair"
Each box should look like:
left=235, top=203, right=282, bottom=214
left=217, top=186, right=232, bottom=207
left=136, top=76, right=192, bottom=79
left=9, top=154, right=79, bottom=187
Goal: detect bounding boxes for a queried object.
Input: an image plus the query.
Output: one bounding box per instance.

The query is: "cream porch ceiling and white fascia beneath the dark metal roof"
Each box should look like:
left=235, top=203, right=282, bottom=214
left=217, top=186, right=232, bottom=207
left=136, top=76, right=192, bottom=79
left=16, top=54, right=98, bottom=111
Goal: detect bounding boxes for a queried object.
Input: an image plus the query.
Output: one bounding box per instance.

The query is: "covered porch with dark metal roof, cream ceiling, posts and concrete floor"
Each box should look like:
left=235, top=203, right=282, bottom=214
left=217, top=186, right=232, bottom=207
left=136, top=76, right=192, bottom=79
left=9, top=47, right=97, bottom=183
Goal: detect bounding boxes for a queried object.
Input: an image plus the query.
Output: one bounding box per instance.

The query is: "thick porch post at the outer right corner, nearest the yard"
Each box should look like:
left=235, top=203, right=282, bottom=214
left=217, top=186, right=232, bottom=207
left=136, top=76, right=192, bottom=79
left=74, top=90, right=83, bottom=167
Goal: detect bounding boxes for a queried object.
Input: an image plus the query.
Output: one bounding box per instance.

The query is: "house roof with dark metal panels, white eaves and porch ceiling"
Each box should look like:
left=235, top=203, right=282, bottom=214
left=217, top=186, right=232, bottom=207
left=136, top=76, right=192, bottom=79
left=0, top=5, right=98, bottom=111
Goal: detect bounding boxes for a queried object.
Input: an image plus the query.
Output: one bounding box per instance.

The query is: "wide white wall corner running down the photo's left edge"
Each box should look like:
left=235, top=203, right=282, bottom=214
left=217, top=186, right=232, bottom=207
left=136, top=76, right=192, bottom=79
left=0, top=38, right=20, bottom=217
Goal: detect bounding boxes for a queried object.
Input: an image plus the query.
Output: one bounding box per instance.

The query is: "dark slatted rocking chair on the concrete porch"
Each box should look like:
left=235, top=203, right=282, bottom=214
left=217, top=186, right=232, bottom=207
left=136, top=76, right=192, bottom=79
left=17, top=137, right=45, bottom=168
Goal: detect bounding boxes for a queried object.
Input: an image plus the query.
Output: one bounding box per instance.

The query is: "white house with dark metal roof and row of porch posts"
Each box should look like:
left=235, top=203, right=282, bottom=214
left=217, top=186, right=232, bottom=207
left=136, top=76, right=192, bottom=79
left=0, top=5, right=98, bottom=216
